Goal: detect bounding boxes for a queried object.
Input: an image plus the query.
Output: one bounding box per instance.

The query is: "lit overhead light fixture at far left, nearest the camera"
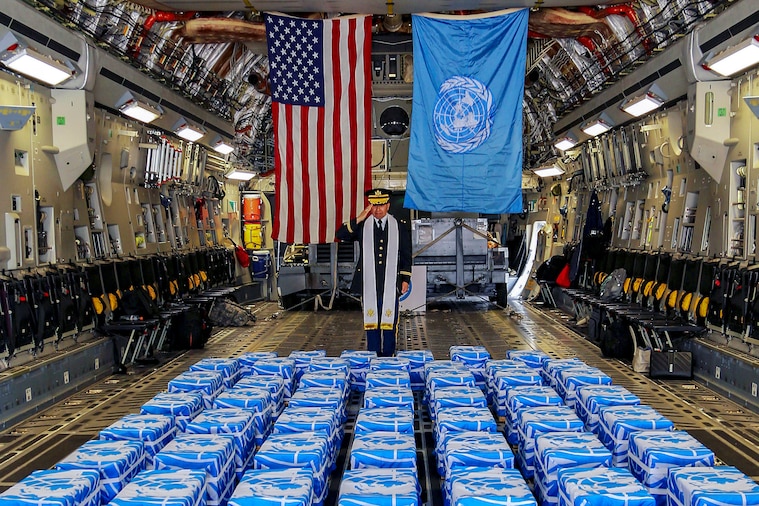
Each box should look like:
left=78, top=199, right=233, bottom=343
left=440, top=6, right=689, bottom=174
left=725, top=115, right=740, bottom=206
left=0, top=29, right=77, bottom=86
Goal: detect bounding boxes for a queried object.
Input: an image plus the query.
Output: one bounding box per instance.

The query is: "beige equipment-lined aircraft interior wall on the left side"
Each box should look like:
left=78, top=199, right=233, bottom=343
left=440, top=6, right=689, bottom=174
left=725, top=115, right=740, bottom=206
left=0, top=68, right=246, bottom=276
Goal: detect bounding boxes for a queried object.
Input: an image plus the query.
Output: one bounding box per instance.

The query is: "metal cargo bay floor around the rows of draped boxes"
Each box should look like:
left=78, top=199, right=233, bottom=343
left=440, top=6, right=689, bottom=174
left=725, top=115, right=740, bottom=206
left=0, top=300, right=759, bottom=506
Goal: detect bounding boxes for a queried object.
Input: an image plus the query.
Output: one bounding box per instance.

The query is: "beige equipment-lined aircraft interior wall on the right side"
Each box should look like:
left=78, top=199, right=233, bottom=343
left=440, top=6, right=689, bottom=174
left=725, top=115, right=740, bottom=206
left=524, top=73, right=759, bottom=261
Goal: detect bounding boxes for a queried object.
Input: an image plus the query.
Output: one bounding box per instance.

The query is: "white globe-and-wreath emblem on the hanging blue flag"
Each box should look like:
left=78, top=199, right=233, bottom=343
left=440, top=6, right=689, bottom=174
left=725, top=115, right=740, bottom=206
left=432, top=76, right=495, bottom=153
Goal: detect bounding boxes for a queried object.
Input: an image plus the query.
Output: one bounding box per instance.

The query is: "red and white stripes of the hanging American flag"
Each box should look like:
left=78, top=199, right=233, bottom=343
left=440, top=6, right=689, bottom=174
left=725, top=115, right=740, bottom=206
left=272, top=16, right=372, bottom=244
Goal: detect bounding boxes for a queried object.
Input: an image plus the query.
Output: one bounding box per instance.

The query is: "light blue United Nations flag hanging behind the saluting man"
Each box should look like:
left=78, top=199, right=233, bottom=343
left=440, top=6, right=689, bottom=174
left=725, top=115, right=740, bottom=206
left=404, top=9, right=529, bottom=214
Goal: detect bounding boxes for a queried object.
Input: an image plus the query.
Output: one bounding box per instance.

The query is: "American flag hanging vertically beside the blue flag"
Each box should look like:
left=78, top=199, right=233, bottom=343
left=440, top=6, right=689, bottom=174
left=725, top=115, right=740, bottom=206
left=266, top=14, right=371, bottom=243
